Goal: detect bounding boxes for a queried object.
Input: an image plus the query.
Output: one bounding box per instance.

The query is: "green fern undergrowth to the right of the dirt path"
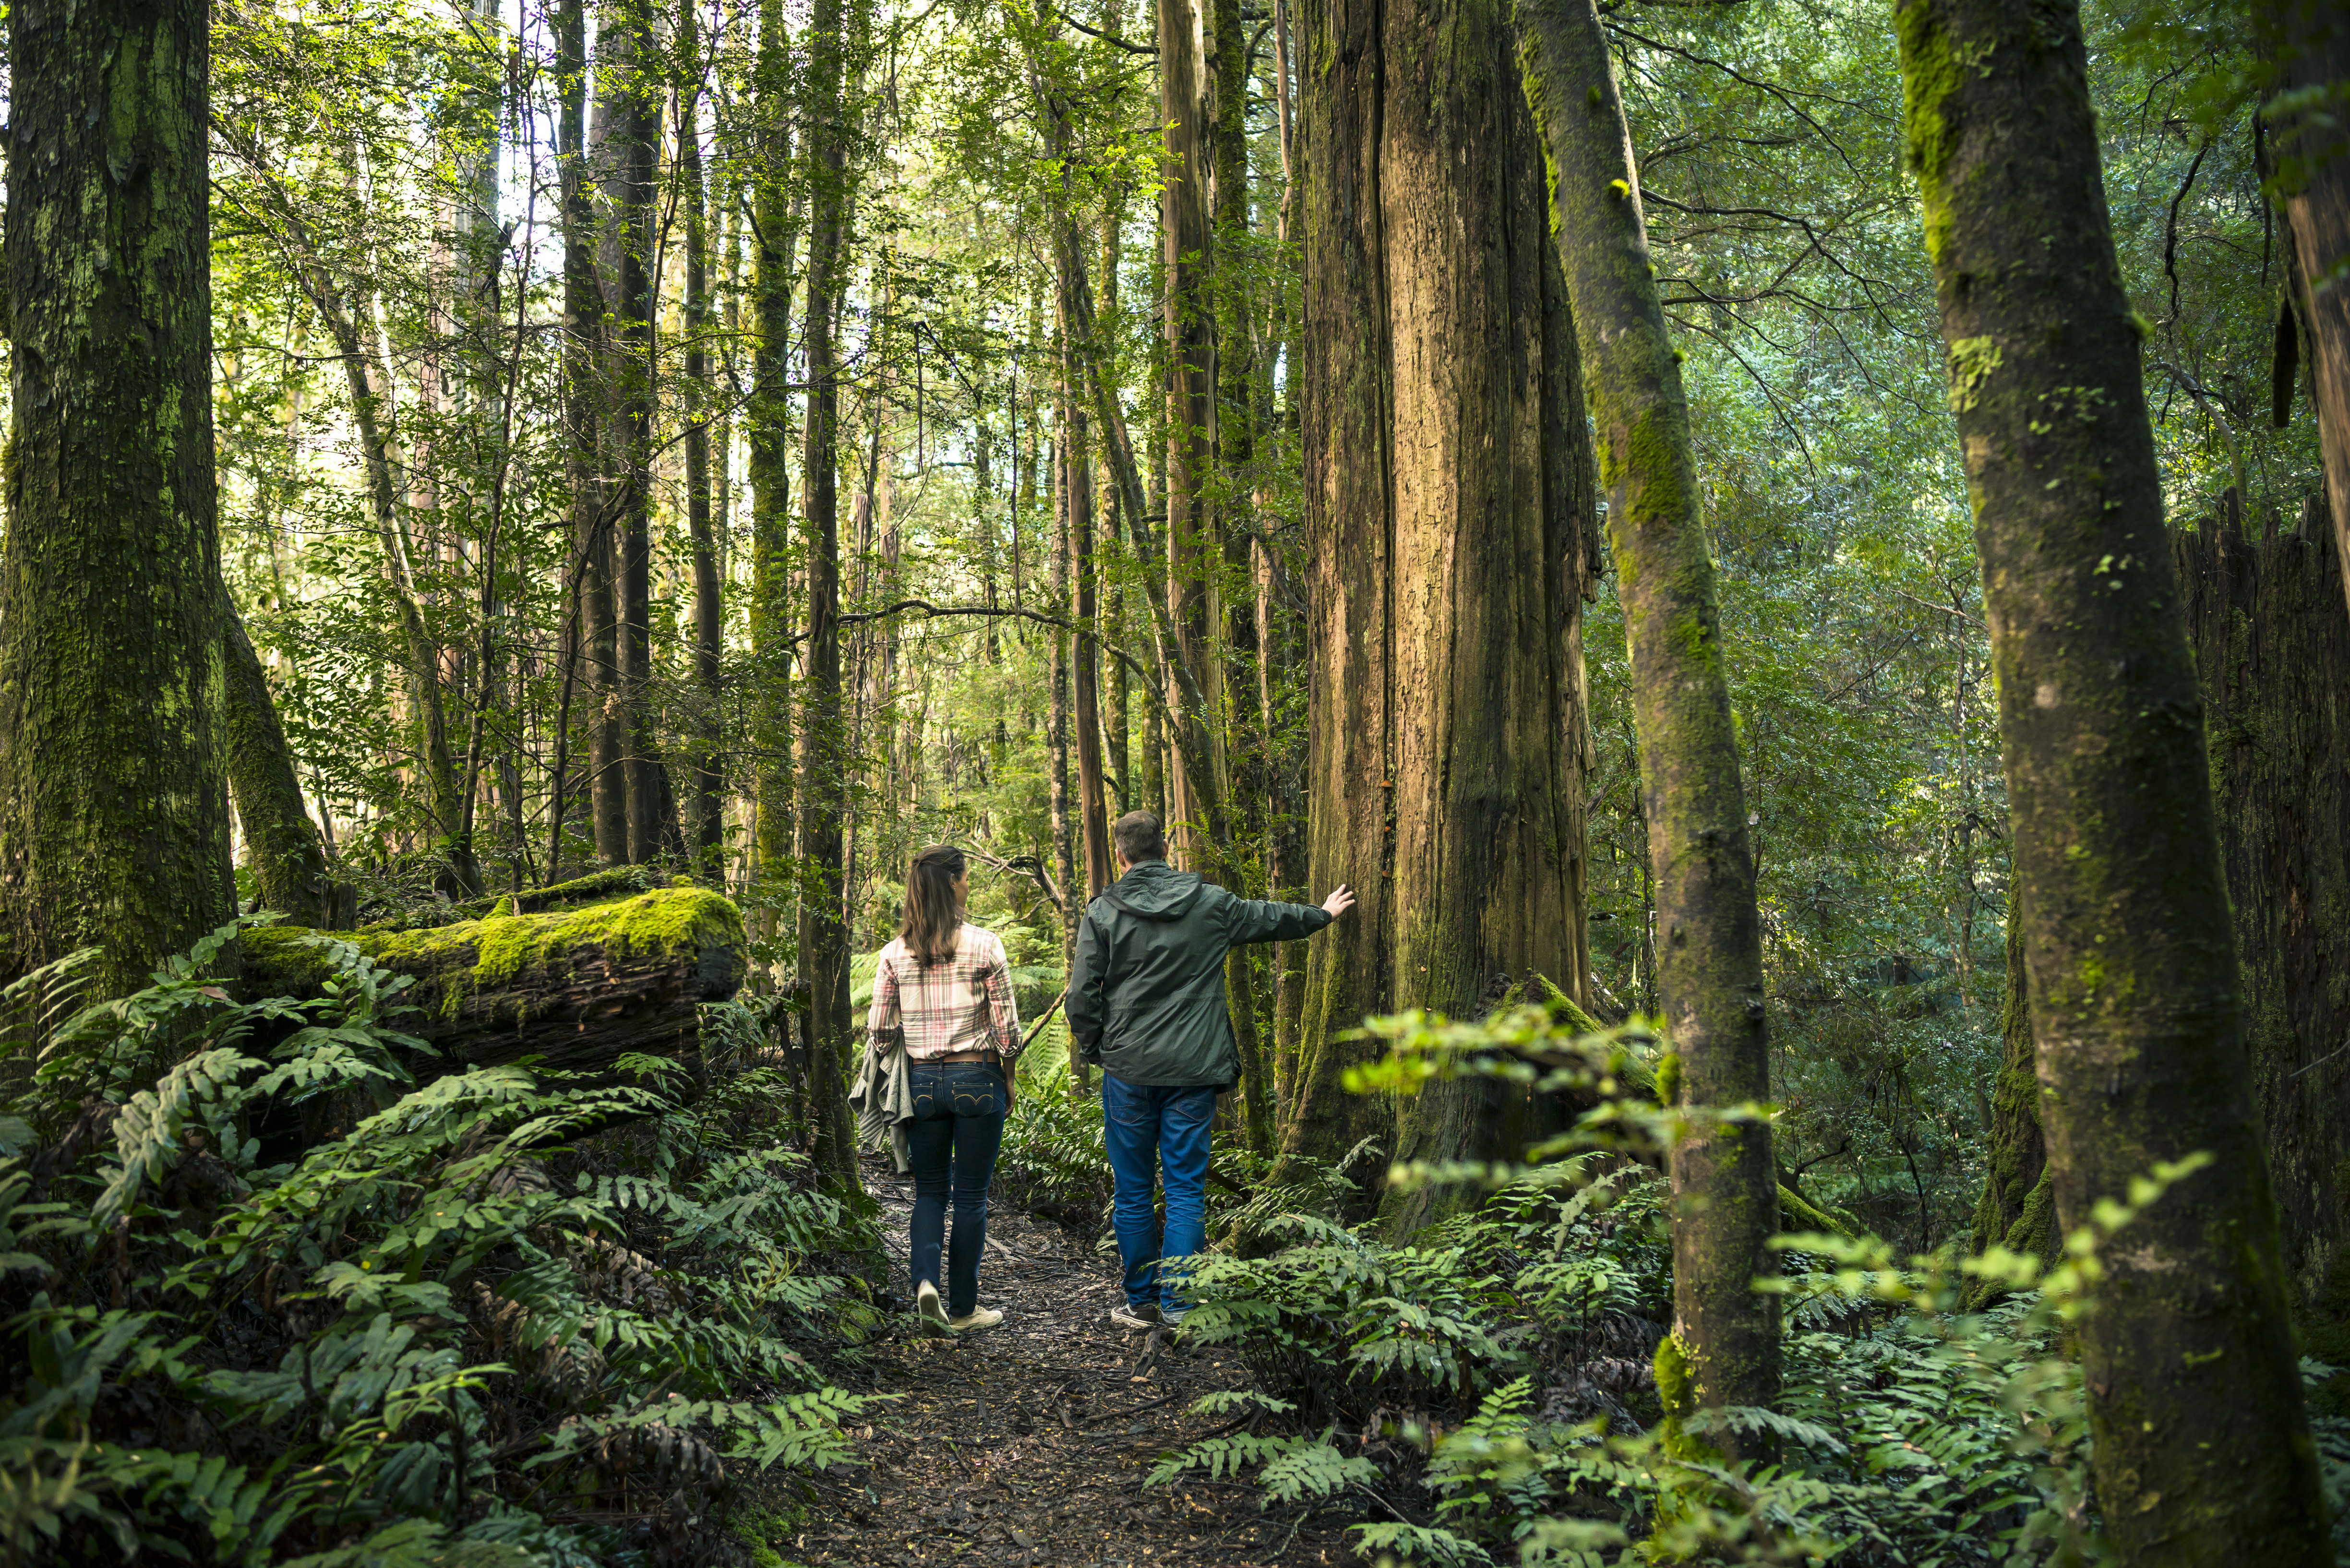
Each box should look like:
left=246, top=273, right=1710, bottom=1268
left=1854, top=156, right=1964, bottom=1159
left=987, top=1006, right=2350, bottom=1568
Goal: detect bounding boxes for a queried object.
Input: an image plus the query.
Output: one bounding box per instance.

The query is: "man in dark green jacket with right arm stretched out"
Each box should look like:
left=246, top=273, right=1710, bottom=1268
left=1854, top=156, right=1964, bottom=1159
left=1069, top=811, right=1354, bottom=1328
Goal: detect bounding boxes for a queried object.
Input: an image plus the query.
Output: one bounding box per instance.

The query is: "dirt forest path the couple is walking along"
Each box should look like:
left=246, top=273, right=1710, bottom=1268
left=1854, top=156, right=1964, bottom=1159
left=771, top=1161, right=1367, bottom=1568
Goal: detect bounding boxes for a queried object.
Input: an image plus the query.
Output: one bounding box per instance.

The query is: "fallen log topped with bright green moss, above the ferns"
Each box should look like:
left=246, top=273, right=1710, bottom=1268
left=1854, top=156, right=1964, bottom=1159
left=244, top=886, right=745, bottom=1077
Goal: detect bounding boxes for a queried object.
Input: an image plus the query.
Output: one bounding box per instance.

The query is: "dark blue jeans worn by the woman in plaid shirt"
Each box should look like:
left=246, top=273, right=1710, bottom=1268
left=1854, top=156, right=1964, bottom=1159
left=905, top=1063, right=1010, bottom=1317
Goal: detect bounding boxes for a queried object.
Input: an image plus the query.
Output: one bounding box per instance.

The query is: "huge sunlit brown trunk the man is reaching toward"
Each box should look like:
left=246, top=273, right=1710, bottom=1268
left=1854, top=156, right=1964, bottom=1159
left=1285, top=0, right=1591, bottom=1230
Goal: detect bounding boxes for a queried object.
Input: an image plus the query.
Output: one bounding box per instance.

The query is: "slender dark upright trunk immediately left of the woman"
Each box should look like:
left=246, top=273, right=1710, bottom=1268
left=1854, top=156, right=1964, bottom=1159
left=799, top=0, right=858, bottom=1187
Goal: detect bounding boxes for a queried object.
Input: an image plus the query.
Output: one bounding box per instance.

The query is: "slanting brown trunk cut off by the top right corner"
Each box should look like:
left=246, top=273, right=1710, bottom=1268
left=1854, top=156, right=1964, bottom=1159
left=2254, top=0, right=2350, bottom=621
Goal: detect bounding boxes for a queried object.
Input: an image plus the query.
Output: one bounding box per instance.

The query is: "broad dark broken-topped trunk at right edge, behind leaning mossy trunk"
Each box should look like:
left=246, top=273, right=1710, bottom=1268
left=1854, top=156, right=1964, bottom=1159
left=2171, top=503, right=2350, bottom=1335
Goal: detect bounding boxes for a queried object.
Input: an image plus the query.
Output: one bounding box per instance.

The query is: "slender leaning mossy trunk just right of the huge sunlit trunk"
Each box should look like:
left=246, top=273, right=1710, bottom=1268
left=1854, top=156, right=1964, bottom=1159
left=1518, top=0, right=1779, bottom=1438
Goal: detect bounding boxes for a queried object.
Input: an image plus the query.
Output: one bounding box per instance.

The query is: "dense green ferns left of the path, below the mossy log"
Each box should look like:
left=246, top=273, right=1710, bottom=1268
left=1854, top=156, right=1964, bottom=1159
left=0, top=926, right=872, bottom=1566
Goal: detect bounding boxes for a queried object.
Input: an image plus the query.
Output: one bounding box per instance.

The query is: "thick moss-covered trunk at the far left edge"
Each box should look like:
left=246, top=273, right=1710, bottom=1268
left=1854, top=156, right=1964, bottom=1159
left=0, top=0, right=237, bottom=994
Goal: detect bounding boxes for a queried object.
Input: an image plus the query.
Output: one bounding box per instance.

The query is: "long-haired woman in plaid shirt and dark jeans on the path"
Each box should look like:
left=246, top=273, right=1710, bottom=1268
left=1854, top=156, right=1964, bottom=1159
left=865, top=844, right=1020, bottom=1335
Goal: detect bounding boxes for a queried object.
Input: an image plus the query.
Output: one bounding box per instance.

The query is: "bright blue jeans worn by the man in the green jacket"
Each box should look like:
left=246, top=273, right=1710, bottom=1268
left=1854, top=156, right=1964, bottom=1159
left=1102, top=1074, right=1215, bottom=1319
